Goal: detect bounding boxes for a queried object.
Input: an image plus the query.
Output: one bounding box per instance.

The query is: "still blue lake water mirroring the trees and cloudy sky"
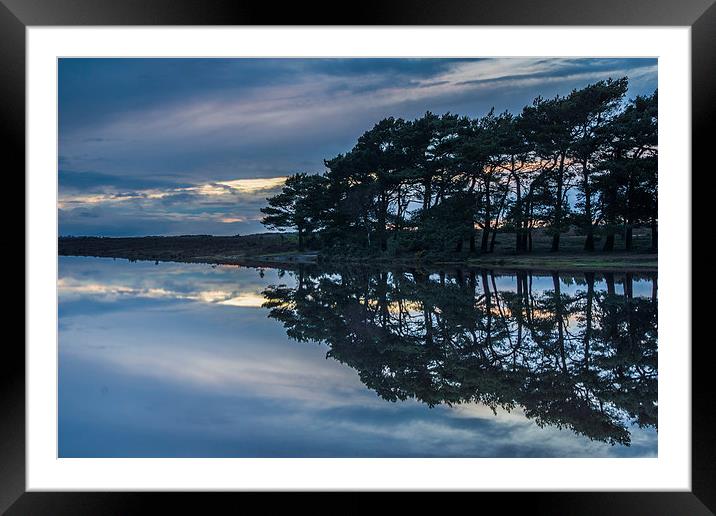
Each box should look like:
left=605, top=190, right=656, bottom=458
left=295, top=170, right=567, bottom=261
left=58, top=257, right=657, bottom=457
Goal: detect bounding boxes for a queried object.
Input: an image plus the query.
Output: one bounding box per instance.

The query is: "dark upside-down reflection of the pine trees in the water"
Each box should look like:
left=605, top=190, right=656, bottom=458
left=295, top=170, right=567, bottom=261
left=264, top=267, right=658, bottom=445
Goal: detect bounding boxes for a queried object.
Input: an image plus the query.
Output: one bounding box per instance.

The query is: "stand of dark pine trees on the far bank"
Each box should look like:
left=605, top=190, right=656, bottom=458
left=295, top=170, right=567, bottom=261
left=261, top=77, right=657, bottom=253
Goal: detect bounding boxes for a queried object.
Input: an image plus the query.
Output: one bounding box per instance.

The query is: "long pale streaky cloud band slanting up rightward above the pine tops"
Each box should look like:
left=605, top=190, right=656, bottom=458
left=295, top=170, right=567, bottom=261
left=64, top=58, right=653, bottom=150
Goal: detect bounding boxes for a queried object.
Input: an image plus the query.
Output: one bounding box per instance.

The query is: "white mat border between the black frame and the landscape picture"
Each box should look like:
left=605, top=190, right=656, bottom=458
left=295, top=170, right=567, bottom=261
left=26, top=27, right=691, bottom=491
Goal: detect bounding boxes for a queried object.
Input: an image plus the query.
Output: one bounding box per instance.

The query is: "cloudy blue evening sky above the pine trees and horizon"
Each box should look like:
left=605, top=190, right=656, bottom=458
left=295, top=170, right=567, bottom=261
left=58, top=58, right=657, bottom=236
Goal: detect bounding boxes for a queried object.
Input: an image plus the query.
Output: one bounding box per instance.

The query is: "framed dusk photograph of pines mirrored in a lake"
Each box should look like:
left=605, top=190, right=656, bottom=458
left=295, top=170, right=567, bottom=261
left=56, top=57, right=660, bottom=460
